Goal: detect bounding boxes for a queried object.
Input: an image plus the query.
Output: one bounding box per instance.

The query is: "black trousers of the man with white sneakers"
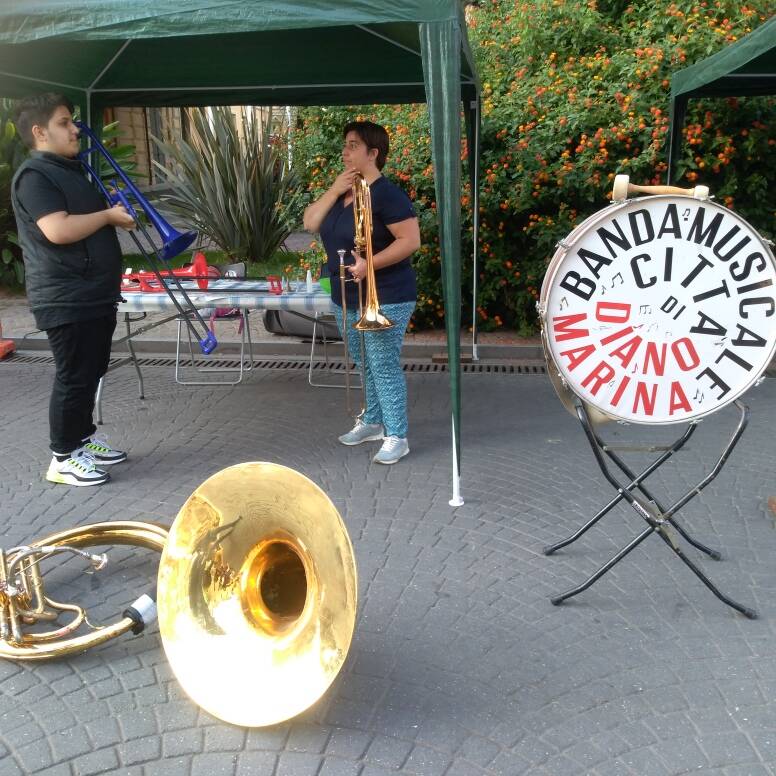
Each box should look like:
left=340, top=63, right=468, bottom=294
left=46, top=312, right=116, bottom=454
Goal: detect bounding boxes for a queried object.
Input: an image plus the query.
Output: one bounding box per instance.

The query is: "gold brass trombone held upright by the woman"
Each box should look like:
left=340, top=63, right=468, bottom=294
left=337, top=172, right=394, bottom=419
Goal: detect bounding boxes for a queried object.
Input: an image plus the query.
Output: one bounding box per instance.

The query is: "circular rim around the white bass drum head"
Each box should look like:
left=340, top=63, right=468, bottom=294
left=539, top=194, right=776, bottom=426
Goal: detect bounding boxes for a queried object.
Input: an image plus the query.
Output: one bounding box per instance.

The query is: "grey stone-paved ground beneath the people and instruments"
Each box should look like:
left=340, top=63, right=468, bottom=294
left=0, top=354, right=776, bottom=776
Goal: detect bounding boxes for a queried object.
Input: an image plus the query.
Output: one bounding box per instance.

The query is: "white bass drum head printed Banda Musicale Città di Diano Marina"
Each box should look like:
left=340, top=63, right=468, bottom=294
left=539, top=195, right=776, bottom=424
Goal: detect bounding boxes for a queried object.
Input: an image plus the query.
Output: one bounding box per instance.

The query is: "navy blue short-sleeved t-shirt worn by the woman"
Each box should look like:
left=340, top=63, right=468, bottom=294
left=321, top=176, right=417, bottom=309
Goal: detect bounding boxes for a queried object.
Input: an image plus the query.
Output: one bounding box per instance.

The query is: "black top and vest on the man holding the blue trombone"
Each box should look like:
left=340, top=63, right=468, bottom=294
left=12, top=152, right=121, bottom=330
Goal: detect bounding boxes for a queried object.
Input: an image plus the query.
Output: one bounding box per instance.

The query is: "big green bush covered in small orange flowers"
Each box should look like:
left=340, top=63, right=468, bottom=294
left=295, top=0, right=776, bottom=334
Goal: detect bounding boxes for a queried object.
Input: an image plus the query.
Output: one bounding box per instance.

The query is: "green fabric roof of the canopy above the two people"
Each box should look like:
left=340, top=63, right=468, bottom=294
left=0, top=0, right=477, bottom=106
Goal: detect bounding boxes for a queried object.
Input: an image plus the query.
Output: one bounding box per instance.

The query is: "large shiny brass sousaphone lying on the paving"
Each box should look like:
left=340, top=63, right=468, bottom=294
left=0, top=463, right=357, bottom=727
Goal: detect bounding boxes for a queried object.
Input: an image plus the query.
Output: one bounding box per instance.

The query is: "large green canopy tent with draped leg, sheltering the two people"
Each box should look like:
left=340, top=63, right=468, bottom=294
left=0, top=0, right=480, bottom=505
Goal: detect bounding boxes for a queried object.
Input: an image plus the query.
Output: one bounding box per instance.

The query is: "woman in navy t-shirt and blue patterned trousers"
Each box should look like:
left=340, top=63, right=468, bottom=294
left=304, top=121, right=420, bottom=464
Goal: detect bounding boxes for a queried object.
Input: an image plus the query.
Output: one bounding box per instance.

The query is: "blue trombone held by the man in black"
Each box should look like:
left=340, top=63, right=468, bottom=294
left=75, top=121, right=218, bottom=355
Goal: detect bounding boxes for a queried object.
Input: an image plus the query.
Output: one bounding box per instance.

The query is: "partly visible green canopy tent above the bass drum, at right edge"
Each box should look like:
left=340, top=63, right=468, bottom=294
left=668, top=16, right=776, bottom=183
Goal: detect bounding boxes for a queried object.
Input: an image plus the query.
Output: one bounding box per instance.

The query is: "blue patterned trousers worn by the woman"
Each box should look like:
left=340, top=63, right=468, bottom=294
left=334, top=302, right=415, bottom=438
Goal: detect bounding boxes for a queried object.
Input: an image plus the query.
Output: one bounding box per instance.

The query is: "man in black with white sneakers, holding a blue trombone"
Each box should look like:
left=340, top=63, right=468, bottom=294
left=11, top=93, right=135, bottom=486
